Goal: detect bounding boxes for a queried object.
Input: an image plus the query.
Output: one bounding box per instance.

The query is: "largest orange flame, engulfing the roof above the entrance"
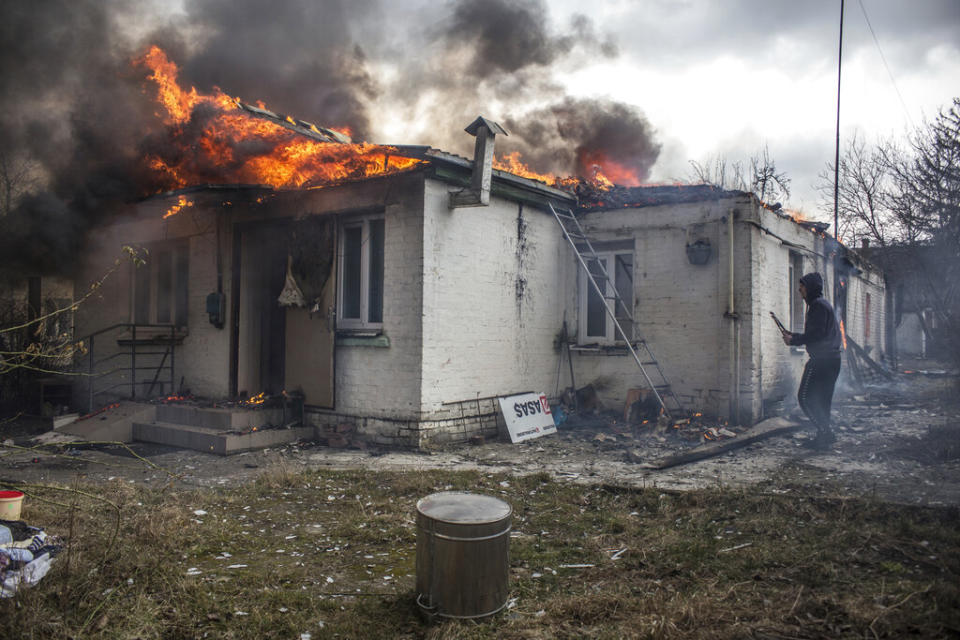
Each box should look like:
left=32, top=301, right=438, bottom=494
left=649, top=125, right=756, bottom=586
left=135, top=46, right=422, bottom=191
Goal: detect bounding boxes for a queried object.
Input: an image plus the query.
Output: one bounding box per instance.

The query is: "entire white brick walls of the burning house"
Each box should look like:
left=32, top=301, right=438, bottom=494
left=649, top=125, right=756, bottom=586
left=77, top=173, right=884, bottom=446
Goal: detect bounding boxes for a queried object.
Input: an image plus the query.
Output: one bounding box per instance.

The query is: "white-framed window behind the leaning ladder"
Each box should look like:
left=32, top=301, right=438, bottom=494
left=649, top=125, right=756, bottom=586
left=580, top=252, right=633, bottom=344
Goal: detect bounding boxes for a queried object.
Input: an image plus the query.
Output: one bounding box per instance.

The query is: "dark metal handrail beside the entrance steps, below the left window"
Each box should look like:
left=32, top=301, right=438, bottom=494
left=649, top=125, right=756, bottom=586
left=81, top=322, right=177, bottom=411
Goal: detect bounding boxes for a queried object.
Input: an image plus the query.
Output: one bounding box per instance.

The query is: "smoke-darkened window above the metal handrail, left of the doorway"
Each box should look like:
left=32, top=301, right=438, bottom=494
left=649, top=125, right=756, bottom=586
left=133, top=242, right=190, bottom=327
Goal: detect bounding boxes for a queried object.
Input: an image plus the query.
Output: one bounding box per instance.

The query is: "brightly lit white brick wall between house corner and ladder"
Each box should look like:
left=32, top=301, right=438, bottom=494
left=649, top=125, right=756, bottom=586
left=414, top=176, right=572, bottom=440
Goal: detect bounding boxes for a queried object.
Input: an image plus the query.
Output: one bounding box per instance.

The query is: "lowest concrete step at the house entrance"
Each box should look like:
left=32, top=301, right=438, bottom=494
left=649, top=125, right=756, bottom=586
left=133, top=421, right=314, bottom=456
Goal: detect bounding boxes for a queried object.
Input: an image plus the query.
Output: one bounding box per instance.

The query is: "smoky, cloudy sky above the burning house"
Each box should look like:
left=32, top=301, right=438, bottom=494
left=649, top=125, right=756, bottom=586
left=0, top=0, right=960, bottom=230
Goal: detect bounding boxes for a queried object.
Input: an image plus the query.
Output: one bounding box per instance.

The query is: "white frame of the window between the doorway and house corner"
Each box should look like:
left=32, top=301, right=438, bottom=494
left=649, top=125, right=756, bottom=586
left=337, top=213, right=386, bottom=333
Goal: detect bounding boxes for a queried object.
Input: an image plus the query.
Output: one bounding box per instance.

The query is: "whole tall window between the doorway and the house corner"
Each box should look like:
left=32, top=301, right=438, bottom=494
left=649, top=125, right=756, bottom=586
left=338, top=216, right=384, bottom=330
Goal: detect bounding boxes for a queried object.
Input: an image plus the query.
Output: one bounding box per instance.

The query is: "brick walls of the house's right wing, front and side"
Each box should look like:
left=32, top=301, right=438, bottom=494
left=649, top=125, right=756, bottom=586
left=568, top=196, right=885, bottom=424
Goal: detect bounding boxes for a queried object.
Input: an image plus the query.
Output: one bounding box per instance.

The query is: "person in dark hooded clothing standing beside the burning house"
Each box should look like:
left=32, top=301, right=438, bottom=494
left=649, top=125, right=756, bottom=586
left=782, top=272, right=842, bottom=450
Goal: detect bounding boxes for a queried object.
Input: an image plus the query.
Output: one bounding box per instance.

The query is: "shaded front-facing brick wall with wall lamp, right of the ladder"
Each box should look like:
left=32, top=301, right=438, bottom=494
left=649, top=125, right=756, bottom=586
left=569, top=199, right=749, bottom=415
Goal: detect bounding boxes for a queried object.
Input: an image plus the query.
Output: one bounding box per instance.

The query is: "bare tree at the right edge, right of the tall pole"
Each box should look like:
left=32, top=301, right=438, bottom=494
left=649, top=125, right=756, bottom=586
left=818, top=99, right=960, bottom=364
